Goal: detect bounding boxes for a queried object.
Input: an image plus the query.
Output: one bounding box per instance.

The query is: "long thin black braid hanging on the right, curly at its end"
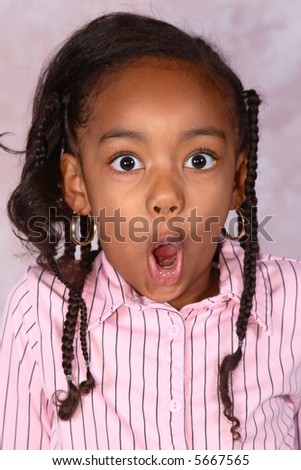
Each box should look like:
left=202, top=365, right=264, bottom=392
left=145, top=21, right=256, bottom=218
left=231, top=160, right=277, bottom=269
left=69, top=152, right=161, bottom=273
left=219, top=90, right=260, bottom=440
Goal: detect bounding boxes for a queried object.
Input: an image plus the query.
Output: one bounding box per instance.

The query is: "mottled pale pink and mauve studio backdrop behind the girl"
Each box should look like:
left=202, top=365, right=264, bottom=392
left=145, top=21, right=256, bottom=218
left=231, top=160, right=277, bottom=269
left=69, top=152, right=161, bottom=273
left=0, top=0, right=301, bottom=317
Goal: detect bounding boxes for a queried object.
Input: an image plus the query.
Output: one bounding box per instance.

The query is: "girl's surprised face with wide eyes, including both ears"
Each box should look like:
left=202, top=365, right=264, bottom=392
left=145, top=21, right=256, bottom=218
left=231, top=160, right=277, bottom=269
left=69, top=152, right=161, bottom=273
left=61, top=58, right=245, bottom=309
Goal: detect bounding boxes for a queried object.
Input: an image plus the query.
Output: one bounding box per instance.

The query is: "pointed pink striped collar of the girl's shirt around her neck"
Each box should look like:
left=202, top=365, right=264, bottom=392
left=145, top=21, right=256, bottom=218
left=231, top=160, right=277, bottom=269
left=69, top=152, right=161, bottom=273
left=83, top=239, right=271, bottom=335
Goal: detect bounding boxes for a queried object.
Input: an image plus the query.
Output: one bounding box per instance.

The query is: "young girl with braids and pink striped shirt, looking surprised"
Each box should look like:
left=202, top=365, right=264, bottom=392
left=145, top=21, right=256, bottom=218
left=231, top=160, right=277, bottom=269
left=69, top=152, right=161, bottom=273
left=0, top=14, right=301, bottom=449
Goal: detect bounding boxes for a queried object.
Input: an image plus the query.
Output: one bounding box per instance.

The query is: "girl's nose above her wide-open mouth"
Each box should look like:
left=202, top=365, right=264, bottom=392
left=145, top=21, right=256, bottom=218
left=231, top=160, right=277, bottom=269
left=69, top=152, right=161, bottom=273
left=147, top=174, right=184, bottom=216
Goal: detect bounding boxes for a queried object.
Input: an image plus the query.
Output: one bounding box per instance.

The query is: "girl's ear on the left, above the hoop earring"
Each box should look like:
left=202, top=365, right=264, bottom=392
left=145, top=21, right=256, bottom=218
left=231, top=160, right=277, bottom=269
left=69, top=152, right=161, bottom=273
left=60, top=153, right=91, bottom=215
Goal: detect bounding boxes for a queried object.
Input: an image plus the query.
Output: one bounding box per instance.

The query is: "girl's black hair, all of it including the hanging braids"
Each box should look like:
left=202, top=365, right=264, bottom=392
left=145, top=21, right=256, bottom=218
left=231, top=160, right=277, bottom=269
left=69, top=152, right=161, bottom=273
left=3, top=13, right=260, bottom=439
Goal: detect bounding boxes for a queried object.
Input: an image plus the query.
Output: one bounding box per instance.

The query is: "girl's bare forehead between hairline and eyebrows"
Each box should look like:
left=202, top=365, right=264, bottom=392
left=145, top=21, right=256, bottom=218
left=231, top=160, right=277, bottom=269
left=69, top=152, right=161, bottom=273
left=82, top=58, right=236, bottom=141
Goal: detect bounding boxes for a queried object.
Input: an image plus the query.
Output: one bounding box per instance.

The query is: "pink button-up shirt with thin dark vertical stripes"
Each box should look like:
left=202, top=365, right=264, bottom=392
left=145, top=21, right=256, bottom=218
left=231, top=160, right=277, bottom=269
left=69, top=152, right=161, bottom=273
left=0, top=241, right=301, bottom=450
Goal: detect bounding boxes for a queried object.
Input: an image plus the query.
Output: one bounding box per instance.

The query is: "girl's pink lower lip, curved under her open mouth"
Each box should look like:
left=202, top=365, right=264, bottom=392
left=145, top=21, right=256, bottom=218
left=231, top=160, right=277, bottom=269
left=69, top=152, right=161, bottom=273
left=149, top=246, right=183, bottom=286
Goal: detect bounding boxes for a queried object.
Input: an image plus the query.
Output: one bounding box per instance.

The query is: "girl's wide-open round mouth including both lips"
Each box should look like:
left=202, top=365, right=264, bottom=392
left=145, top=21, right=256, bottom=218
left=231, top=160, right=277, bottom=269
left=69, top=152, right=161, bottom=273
left=149, top=241, right=183, bottom=285
